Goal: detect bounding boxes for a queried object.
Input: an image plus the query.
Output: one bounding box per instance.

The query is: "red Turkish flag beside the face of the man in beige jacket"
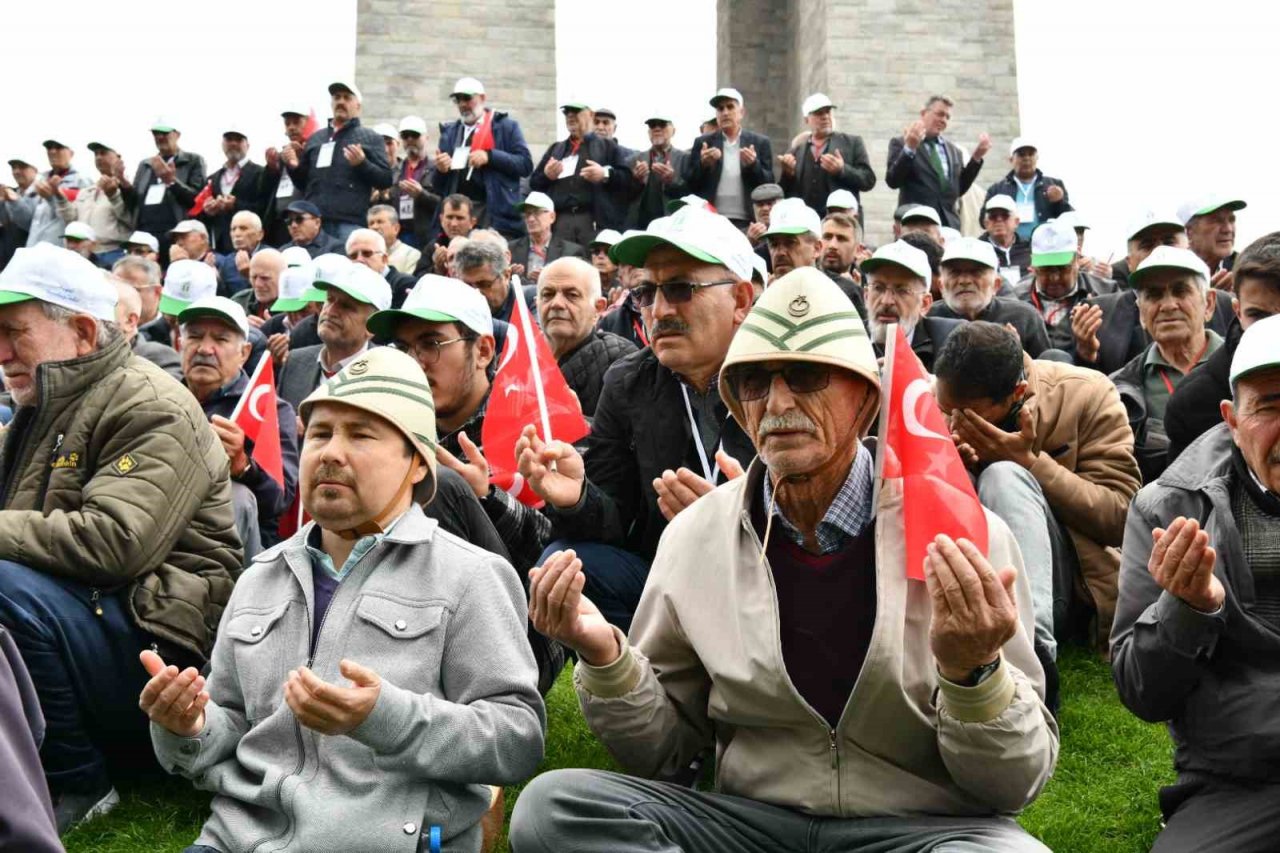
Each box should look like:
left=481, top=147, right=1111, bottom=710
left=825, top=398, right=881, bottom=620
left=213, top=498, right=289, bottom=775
left=879, top=324, right=987, bottom=580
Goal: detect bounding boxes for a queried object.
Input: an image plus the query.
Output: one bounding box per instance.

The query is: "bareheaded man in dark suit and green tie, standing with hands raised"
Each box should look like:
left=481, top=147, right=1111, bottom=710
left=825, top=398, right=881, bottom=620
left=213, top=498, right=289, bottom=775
left=884, top=95, right=991, bottom=228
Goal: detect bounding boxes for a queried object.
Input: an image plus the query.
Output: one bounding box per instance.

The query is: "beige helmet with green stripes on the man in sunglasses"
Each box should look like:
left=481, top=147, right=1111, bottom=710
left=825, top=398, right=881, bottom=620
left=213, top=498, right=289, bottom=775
left=719, top=266, right=880, bottom=432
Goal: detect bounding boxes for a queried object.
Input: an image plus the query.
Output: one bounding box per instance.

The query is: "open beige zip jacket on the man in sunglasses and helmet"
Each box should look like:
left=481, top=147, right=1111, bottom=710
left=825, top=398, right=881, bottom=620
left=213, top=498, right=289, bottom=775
left=575, top=460, right=1057, bottom=817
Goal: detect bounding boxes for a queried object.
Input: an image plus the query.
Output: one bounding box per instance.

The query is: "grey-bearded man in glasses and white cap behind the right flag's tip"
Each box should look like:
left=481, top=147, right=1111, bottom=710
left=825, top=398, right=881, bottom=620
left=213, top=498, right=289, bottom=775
left=861, top=240, right=964, bottom=373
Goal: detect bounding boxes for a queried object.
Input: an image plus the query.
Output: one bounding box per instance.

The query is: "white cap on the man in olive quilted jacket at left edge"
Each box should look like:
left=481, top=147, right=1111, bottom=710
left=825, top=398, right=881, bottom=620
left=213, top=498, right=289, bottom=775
left=0, top=243, right=118, bottom=323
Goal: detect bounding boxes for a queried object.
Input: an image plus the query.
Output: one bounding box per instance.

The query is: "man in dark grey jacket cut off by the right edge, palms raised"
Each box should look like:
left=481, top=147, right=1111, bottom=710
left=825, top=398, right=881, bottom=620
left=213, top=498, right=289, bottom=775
left=1111, top=308, right=1280, bottom=853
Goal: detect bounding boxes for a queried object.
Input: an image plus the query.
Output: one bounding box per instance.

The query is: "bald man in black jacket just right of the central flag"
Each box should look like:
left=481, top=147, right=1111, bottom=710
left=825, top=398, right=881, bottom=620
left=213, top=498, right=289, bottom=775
left=538, top=256, right=636, bottom=418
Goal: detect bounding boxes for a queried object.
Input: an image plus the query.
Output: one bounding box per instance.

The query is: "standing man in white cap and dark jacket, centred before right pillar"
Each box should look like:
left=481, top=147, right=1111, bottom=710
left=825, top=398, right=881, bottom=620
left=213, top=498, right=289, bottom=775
left=778, top=92, right=876, bottom=216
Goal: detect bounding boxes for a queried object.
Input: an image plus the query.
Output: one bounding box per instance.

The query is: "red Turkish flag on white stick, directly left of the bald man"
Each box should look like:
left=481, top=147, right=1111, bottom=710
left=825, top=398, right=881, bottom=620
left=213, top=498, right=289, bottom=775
left=480, top=282, right=590, bottom=507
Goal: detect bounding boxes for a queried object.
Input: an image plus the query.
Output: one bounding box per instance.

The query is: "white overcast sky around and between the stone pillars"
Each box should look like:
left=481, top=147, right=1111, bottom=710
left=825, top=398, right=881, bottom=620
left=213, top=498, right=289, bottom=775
left=0, top=0, right=1280, bottom=257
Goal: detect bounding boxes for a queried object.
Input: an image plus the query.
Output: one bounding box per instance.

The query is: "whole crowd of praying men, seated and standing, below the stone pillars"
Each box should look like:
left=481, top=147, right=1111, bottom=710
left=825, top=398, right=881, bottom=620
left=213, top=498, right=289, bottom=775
left=0, top=77, right=1280, bottom=853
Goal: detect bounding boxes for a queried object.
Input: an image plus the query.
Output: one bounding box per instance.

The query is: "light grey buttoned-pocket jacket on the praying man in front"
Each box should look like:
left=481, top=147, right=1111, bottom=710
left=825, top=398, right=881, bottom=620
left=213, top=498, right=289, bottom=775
left=151, top=505, right=547, bottom=853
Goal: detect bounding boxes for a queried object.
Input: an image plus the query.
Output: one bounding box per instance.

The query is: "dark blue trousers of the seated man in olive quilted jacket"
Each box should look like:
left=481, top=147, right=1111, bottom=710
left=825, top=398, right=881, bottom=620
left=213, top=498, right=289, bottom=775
left=0, top=561, right=155, bottom=795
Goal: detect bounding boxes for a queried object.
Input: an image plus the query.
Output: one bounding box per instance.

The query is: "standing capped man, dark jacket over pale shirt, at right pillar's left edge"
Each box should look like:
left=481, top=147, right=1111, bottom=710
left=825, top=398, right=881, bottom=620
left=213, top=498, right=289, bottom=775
left=684, top=88, right=773, bottom=228
